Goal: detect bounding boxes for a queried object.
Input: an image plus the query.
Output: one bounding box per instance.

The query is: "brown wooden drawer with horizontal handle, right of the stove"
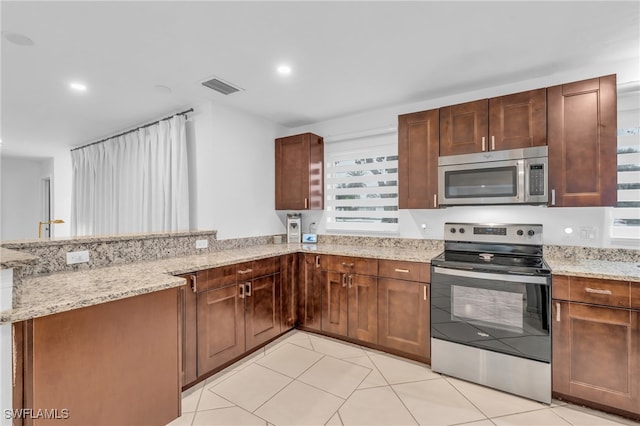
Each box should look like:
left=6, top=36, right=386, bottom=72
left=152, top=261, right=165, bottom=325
left=552, top=275, right=631, bottom=308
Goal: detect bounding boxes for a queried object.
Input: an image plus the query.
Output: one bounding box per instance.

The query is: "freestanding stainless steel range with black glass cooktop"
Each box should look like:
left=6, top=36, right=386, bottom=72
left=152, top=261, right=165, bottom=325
left=431, top=223, right=551, bottom=403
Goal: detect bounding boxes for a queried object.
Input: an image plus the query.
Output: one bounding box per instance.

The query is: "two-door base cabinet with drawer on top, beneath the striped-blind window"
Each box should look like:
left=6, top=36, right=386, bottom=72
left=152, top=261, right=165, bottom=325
left=321, top=256, right=378, bottom=343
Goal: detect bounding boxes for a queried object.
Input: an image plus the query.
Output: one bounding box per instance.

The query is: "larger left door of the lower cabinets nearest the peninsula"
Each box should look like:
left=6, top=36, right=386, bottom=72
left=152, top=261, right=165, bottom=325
left=197, top=285, right=245, bottom=376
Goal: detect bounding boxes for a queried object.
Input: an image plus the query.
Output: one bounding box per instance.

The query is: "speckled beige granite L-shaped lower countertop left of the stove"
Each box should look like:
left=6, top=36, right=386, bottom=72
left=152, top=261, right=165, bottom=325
left=0, top=244, right=439, bottom=324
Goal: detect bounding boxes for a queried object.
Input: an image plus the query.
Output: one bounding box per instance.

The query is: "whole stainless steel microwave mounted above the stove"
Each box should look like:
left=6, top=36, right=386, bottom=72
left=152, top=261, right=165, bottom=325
left=438, top=146, right=549, bottom=206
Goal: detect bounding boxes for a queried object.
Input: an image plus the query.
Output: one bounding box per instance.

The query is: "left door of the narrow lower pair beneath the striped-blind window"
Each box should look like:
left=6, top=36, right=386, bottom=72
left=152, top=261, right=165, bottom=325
left=321, top=271, right=348, bottom=336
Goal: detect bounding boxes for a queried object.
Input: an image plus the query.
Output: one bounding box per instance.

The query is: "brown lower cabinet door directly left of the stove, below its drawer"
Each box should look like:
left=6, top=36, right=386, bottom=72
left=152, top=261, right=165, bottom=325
left=378, top=278, right=431, bottom=359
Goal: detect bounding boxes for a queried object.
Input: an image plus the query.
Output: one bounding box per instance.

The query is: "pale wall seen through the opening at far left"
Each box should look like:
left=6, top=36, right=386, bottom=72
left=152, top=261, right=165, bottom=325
left=0, top=157, right=52, bottom=240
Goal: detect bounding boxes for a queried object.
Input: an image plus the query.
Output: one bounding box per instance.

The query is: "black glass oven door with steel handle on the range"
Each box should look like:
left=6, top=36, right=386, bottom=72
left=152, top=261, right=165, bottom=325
left=431, top=266, right=551, bottom=363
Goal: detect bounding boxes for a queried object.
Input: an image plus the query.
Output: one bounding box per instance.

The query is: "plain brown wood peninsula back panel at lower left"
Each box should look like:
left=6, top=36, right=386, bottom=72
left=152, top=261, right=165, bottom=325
left=13, top=288, right=181, bottom=426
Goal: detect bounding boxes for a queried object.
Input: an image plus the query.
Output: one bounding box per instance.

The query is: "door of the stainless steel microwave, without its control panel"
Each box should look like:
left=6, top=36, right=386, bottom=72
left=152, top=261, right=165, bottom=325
left=438, top=160, right=526, bottom=205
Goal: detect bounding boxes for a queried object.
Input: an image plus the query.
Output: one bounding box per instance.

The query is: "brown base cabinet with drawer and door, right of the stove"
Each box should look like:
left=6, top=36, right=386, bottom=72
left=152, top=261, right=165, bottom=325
left=552, top=275, right=640, bottom=419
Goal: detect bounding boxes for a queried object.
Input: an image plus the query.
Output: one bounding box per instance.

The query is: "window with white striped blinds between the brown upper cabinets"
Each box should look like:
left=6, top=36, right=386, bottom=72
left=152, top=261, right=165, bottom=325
left=325, top=129, right=398, bottom=232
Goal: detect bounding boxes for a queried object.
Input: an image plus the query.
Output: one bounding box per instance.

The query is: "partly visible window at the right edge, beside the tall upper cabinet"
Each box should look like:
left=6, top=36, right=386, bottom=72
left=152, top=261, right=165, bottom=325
left=611, top=83, right=640, bottom=242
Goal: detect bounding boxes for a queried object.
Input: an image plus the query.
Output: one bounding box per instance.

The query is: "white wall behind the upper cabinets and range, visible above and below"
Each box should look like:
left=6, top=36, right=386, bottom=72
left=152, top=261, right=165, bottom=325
left=288, top=61, right=640, bottom=247
